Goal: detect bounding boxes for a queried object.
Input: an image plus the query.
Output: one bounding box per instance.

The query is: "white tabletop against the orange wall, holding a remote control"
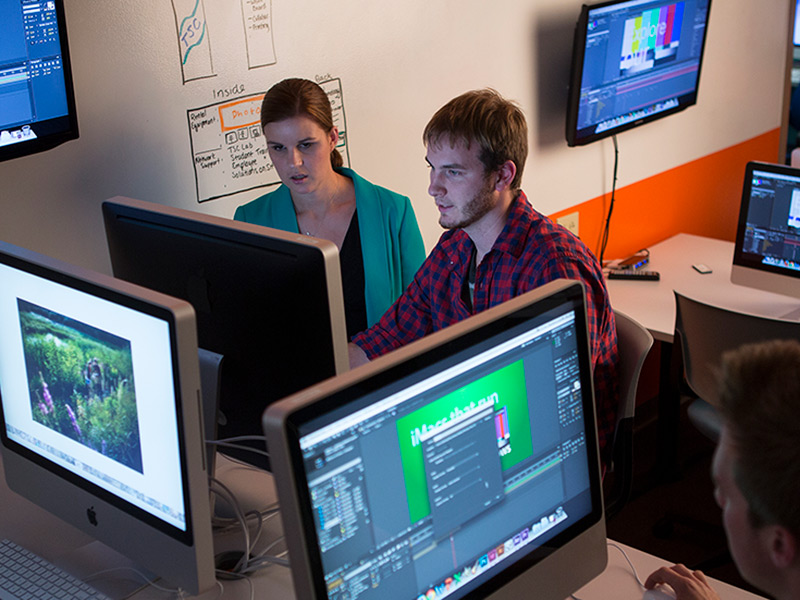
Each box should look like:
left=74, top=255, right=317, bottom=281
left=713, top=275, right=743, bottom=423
left=606, top=233, right=800, bottom=342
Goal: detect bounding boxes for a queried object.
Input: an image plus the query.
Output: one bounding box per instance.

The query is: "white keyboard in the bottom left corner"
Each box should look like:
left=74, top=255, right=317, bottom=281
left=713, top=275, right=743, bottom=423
left=0, top=540, right=111, bottom=600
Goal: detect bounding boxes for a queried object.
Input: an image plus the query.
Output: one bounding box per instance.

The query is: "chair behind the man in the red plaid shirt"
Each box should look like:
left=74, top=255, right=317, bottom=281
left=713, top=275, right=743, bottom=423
left=605, top=311, right=653, bottom=519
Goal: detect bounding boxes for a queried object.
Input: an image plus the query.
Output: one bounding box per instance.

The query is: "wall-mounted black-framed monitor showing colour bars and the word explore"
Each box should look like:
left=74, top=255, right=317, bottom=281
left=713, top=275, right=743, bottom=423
left=566, top=0, right=711, bottom=146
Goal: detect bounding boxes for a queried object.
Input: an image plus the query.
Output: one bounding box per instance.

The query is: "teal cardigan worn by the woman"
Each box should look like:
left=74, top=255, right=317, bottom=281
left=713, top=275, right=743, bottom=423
left=233, top=167, right=425, bottom=327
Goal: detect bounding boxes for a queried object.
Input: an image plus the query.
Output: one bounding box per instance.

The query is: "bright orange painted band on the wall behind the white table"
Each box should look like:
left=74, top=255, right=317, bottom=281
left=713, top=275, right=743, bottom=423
left=550, top=129, right=780, bottom=259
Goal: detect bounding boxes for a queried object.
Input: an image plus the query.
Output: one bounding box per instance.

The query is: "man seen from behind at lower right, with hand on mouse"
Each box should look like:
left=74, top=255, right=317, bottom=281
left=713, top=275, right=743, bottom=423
left=645, top=340, right=800, bottom=600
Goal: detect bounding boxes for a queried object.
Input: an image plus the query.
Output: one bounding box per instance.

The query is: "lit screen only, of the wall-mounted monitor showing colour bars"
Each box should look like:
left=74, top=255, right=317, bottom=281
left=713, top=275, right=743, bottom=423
left=578, top=0, right=708, bottom=133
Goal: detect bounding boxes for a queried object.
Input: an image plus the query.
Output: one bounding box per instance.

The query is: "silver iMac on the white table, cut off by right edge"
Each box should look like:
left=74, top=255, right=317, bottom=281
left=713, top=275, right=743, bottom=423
left=731, top=162, right=800, bottom=314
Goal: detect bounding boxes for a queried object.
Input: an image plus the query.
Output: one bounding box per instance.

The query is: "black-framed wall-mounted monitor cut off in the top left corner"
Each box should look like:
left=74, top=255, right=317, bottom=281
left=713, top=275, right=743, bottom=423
left=0, top=0, right=78, bottom=160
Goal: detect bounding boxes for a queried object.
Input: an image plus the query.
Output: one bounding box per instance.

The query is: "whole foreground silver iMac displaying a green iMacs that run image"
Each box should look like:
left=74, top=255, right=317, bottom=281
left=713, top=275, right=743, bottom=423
left=264, top=280, right=607, bottom=600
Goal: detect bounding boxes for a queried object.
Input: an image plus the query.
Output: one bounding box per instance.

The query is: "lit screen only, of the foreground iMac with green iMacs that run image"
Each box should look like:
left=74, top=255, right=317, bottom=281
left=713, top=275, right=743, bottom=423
left=301, top=312, right=591, bottom=600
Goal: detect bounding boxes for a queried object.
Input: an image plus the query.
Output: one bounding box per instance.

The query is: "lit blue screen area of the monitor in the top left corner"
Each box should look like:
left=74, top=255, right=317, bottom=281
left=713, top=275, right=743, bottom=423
left=0, top=0, right=67, bottom=146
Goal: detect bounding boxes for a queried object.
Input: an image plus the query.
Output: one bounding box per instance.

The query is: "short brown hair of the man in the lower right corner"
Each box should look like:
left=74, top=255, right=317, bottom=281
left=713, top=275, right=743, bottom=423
left=719, top=340, right=800, bottom=535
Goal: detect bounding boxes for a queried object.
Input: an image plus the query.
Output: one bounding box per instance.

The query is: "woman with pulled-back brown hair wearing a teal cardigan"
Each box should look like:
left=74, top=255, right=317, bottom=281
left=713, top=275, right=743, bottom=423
left=234, top=79, right=425, bottom=337
